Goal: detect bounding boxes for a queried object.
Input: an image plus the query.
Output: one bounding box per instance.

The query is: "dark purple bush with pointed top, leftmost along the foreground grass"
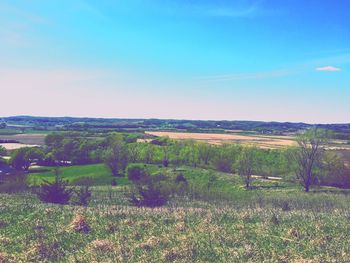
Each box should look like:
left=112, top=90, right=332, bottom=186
left=37, top=169, right=73, bottom=204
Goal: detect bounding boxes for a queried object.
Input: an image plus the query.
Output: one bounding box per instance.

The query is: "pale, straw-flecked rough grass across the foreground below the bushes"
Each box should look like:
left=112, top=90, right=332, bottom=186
left=0, top=194, right=350, bottom=262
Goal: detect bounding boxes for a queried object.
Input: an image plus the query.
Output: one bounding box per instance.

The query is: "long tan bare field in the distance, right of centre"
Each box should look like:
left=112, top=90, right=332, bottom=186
left=145, top=131, right=295, bottom=149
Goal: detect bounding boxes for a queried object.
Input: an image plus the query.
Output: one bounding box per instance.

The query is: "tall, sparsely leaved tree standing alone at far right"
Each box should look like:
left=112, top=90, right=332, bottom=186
left=293, top=128, right=329, bottom=192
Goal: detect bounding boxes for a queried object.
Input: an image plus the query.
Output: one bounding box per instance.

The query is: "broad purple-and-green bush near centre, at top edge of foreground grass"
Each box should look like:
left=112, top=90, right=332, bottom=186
left=129, top=175, right=172, bottom=207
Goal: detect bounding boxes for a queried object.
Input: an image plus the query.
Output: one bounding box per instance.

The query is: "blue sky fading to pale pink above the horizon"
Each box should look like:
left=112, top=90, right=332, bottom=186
left=0, top=0, right=350, bottom=123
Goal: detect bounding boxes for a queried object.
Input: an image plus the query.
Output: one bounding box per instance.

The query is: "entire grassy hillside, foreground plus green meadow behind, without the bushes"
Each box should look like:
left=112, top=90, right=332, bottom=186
left=0, top=164, right=350, bottom=262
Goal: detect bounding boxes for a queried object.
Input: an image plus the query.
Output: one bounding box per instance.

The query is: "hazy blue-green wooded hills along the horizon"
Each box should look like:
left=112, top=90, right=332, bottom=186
left=2, top=116, right=350, bottom=136
